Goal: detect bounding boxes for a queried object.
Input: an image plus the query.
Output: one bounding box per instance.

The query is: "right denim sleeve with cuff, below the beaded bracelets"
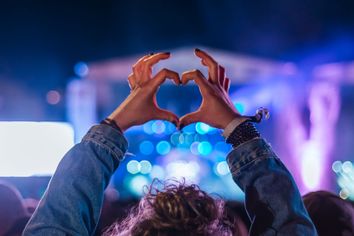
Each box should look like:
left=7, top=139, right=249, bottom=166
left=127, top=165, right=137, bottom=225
left=227, top=138, right=317, bottom=235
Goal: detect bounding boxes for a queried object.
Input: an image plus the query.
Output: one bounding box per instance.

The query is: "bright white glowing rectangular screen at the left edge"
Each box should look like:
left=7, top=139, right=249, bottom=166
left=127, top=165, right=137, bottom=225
left=0, top=122, right=74, bottom=176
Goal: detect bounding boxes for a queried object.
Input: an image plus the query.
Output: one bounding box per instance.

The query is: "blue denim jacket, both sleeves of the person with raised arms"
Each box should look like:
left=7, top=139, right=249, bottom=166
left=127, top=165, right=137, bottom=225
left=23, top=125, right=316, bottom=236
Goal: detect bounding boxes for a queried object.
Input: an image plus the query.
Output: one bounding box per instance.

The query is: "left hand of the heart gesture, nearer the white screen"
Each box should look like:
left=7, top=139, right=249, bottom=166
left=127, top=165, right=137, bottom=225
left=109, top=53, right=181, bottom=131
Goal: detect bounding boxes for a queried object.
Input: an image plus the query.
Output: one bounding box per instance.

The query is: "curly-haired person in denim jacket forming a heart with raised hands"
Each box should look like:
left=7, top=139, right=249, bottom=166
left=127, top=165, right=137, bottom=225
left=24, top=49, right=316, bottom=235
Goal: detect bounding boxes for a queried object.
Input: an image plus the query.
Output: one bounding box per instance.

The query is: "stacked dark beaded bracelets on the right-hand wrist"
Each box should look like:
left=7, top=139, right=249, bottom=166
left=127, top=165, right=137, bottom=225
left=226, top=121, right=261, bottom=148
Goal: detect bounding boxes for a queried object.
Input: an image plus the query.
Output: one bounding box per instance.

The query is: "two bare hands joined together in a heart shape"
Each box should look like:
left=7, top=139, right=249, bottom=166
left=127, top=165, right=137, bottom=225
left=109, top=49, right=244, bottom=131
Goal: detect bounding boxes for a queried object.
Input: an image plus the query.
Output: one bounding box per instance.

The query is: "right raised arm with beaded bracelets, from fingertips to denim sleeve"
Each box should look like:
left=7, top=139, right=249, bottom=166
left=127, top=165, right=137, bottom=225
left=180, top=49, right=317, bottom=235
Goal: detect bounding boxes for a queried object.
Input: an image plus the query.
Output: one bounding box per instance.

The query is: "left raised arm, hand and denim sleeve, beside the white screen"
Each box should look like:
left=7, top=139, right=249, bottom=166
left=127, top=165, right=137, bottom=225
left=24, top=53, right=179, bottom=235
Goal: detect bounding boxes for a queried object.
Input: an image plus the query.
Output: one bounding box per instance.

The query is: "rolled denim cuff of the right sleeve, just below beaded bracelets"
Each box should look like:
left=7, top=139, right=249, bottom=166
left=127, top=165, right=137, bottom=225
left=226, top=138, right=278, bottom=176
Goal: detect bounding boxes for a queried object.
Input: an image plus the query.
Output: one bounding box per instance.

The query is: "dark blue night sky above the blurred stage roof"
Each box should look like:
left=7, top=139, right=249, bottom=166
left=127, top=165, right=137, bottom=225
left=0, top=0, right=354, bottom=89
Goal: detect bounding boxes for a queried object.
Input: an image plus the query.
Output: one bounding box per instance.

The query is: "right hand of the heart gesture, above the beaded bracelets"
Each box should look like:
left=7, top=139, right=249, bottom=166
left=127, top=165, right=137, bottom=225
left=179, top=49, right=247, bottom=129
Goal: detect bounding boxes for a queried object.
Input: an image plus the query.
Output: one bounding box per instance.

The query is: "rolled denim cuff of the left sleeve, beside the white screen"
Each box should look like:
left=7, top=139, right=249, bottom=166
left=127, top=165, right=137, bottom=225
left=82, top=124, right=128, bottom=161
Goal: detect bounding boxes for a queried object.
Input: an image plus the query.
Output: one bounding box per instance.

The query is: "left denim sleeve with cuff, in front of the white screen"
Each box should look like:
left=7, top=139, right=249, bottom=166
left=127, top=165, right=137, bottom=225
left=23, top=125, right=128, bottom=235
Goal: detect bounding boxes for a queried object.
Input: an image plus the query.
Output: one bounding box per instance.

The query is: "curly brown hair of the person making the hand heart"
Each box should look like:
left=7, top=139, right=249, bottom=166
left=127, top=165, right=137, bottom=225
left=103, top=180, right=238, bottom=236
